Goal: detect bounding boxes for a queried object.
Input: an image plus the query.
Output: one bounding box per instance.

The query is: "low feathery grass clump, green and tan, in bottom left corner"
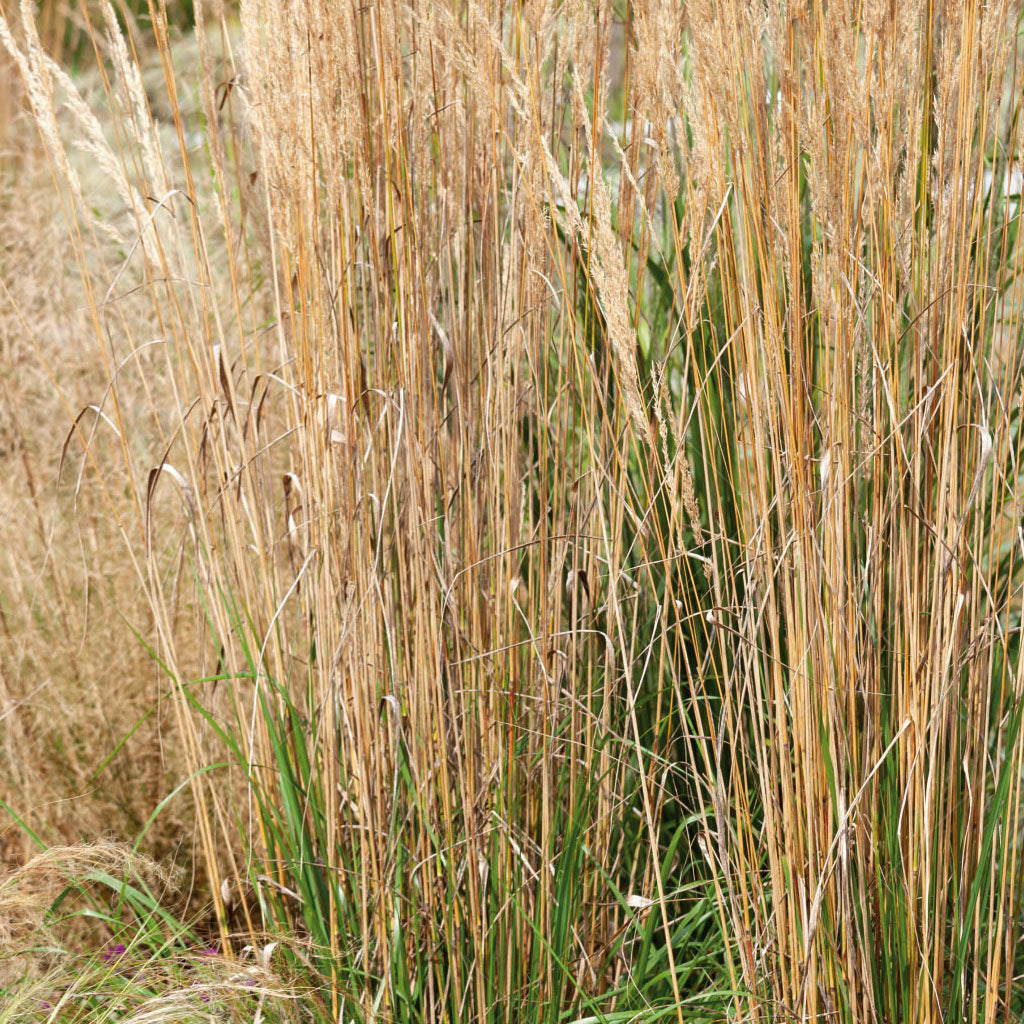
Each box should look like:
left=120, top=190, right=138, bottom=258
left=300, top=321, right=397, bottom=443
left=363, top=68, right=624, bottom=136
left=0, top=842, right=316, bottom=1024
